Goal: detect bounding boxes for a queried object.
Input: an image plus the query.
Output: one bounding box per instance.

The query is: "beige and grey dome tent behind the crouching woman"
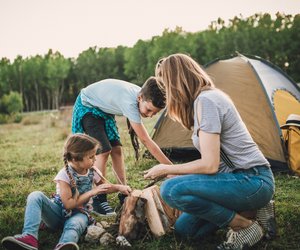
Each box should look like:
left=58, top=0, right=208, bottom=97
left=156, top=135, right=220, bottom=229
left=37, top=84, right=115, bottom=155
left=153, top=54, right=300, bottom=170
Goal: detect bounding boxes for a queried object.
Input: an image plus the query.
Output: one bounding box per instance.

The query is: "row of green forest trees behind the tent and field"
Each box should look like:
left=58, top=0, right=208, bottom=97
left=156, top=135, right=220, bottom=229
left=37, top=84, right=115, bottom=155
left=0, top=13, right=300, bottom=115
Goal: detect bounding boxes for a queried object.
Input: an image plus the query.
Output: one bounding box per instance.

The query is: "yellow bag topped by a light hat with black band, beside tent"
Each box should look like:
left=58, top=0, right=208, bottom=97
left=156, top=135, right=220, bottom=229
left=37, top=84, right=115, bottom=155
left=281, top=114, right=300, bottom=175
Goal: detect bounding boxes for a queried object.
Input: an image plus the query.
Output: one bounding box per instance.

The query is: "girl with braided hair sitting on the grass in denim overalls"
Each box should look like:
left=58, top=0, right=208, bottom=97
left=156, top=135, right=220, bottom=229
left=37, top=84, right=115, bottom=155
left=1, top=134, right=131, bottom=250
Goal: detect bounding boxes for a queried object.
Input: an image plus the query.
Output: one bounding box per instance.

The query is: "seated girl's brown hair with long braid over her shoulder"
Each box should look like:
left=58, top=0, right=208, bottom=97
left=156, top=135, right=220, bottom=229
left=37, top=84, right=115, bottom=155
left=63, top=133, right=99, bottom=197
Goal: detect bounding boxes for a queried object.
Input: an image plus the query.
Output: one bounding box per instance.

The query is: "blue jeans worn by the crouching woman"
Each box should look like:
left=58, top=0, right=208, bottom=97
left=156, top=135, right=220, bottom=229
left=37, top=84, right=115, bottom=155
left=160, top=166, right=275, bottom=239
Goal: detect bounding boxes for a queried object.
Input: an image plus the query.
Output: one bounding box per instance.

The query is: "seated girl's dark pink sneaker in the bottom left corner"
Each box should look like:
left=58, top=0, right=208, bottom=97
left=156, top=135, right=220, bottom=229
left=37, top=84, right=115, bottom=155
left=1, top=234, right=38, bottom=250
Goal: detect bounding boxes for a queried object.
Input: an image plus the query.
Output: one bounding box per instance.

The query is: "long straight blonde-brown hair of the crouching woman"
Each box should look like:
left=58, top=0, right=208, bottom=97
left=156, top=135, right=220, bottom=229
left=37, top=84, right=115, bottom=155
left=155, top=54, right=214, bottom=129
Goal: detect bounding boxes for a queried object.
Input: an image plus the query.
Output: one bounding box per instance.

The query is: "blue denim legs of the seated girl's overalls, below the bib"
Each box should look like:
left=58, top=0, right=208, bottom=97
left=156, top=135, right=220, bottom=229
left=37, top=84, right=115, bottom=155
left=22, top=191, right=88, bottom=243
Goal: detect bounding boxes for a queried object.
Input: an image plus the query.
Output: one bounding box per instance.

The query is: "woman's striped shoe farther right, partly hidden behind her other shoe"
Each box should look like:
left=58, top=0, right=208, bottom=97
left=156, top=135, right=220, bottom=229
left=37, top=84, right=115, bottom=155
left=256, top=200, right=277, bottom=240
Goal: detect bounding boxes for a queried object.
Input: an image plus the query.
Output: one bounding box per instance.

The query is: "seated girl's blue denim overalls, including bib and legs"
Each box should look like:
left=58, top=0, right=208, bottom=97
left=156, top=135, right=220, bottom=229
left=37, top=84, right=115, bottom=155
left=22, top=167, right=94, bottom=243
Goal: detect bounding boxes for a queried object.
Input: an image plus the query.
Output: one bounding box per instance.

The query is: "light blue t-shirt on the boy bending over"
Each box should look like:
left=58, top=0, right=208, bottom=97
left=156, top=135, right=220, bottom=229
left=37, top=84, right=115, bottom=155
left=81, top=79, right=141, bottom=123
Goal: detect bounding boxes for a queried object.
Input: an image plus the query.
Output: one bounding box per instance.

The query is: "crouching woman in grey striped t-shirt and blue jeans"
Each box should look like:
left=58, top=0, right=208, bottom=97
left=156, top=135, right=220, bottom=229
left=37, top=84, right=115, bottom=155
left=145, top=54, right=274, bottom=249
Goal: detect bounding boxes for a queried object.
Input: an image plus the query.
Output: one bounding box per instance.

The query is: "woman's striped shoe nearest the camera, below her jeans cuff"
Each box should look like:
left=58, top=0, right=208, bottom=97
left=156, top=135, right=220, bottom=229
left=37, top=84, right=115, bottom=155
left=217, top=221, right=264, bottom=250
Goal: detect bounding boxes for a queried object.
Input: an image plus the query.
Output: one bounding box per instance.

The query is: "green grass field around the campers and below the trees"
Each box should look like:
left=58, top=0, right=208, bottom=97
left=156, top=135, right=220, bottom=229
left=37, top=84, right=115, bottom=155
left=0, top=110, right=300, bottom=249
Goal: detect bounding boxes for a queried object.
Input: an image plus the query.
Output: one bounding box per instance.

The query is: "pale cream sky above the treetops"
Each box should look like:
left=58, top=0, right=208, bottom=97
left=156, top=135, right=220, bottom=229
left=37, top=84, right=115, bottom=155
left=0, top=0, right=300, bottom=60
